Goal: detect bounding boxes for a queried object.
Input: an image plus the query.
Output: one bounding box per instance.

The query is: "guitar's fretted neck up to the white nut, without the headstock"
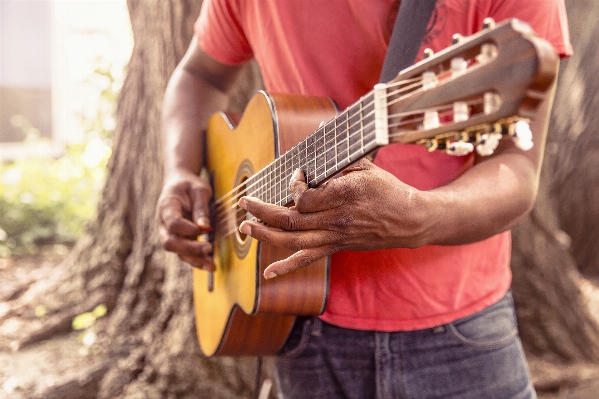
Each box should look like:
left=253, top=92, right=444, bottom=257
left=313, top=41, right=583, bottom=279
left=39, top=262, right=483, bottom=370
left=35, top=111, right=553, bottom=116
left=246, top=89, right=389, bottom=206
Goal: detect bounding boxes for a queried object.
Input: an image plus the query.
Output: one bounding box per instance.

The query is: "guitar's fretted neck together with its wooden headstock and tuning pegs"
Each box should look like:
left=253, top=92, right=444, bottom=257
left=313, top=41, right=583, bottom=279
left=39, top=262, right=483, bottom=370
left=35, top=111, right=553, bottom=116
left=236, top=20, right=558, bottom=209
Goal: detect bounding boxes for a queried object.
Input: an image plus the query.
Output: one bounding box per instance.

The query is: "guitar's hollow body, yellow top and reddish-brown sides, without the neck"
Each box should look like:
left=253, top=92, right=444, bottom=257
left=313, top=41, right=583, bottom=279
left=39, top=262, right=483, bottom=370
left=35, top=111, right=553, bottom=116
left=193, top=92, right=336, bottom=356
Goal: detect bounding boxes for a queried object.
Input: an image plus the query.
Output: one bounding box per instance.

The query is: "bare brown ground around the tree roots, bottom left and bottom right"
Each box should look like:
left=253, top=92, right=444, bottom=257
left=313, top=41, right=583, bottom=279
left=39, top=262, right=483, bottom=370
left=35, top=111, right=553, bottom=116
left=0, top=253, right=599, bottom=399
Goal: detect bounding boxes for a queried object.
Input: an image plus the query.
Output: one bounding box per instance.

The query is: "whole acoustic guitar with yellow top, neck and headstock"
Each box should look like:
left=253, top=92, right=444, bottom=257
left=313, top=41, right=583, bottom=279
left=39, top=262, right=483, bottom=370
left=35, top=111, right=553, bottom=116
left=193, top=19, right=558, bottom=356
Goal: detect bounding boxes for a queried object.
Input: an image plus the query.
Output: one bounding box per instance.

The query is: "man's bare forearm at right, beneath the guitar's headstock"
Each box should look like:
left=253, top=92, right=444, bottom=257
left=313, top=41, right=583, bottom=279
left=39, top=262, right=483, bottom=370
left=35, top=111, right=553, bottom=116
left=414, top=78, right=555, bottom=245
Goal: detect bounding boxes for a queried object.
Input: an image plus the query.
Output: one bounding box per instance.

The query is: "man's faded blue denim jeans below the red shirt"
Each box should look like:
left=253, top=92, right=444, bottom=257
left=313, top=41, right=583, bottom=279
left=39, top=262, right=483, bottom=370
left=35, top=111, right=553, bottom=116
left=275, top=293, right=536, bottom=399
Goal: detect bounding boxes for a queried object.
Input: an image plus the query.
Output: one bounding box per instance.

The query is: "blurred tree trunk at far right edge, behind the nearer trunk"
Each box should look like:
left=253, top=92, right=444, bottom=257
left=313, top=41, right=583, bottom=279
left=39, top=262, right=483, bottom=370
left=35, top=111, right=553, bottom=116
left=551, top=0, right=599, bottom=279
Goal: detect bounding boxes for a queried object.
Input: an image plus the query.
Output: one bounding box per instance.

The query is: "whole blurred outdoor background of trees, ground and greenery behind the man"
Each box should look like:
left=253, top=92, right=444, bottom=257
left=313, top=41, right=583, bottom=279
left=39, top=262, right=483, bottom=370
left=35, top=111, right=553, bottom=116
left=0, top=0, right=599, bottom=399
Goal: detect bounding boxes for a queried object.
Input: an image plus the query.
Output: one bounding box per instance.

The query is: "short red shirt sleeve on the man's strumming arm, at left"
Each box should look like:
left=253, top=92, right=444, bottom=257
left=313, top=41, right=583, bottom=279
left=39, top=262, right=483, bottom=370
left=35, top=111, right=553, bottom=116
left=194, top=0, right=253, bottom=65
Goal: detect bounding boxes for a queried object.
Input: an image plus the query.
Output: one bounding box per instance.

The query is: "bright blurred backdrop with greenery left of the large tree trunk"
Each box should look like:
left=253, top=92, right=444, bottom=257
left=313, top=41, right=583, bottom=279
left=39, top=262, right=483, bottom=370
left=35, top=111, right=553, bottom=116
left=0, top=0, right=133, bottom=257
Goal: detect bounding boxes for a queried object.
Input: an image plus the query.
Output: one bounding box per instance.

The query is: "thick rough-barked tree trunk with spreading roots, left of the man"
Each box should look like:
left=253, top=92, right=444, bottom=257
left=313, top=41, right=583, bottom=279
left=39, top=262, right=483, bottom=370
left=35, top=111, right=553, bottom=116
left=17, top=0, right=261, bottom=399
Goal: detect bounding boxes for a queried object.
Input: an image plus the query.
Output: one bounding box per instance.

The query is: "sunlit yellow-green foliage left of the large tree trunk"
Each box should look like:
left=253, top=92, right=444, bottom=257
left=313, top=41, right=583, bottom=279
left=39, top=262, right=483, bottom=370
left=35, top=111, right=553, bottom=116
left=0, top=62, right=120, bottom=257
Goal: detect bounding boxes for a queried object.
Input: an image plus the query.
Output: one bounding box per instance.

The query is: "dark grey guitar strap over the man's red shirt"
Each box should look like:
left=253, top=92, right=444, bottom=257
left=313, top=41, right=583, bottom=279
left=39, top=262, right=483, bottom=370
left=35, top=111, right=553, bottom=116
left=379, top=0, right=437, bottom=83
